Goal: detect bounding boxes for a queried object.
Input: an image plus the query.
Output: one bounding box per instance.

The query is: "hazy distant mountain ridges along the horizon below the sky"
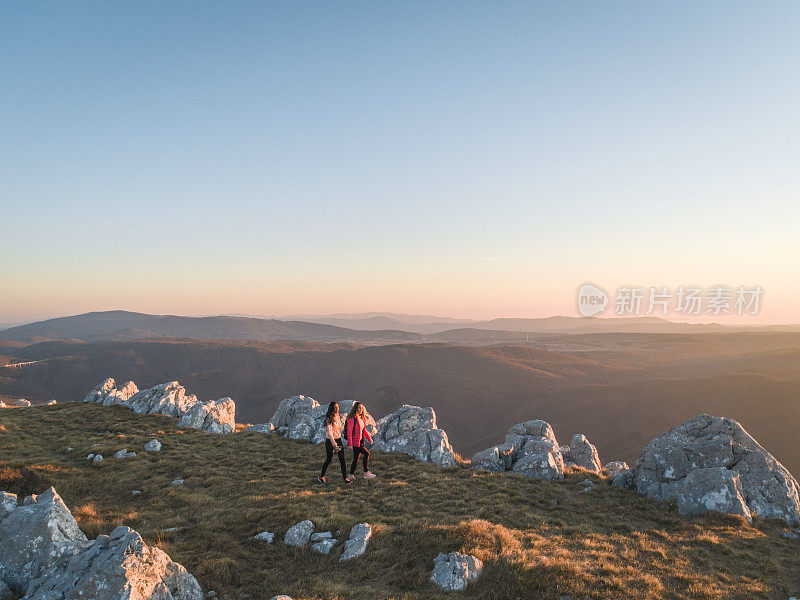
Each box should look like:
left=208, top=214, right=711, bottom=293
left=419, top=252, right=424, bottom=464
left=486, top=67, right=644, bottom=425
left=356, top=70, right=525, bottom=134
left=0, top=310, right=800, bottom=345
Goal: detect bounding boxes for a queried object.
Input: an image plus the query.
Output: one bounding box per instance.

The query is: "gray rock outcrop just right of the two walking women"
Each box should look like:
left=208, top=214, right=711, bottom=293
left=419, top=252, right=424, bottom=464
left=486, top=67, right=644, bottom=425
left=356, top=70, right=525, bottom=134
left=373, top=404, right=458, bottom=467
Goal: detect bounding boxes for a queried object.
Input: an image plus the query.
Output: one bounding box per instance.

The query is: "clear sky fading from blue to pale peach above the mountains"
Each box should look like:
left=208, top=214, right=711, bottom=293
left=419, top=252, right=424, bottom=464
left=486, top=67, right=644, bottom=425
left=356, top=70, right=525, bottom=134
left=0, top=1, right=800, bottom=323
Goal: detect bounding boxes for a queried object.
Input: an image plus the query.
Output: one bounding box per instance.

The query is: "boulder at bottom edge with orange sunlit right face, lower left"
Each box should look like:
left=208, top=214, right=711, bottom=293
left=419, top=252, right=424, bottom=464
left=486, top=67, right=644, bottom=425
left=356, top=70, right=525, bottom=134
left=24, top=527, right=203, bottom=600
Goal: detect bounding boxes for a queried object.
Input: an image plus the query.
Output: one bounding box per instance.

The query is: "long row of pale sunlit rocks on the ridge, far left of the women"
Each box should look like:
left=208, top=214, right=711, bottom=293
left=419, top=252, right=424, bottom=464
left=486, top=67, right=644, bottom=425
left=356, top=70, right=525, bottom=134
left=84, top=377, right=236, bottom=433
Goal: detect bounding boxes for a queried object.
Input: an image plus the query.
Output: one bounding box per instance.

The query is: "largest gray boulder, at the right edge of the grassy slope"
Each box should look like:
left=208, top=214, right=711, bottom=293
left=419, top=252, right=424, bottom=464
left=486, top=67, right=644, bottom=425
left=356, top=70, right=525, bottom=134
left=634, top=415, right=800, bottom=525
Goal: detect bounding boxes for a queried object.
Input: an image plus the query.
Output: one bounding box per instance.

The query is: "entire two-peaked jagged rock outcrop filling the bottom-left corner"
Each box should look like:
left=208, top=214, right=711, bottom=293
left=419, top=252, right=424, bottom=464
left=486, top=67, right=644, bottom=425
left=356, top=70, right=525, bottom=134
left=0, top=488, right=203, bottom=600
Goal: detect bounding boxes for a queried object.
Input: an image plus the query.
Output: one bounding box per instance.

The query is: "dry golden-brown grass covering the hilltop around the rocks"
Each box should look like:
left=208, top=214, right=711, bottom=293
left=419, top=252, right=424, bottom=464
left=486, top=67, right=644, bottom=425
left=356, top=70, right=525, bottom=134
left=0, top=404, right=800, bottom=600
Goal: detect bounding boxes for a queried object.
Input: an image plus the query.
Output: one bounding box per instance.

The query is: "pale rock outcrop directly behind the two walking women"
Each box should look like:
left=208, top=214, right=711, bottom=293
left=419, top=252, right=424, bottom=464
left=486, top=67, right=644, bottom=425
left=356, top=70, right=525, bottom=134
left=270, top=396, right=377, bottom=446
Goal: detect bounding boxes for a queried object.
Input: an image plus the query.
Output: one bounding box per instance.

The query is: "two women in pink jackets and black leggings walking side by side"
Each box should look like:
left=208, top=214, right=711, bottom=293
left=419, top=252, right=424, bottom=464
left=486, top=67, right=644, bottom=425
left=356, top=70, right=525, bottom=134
left=319, top=402, right=375, bottom=485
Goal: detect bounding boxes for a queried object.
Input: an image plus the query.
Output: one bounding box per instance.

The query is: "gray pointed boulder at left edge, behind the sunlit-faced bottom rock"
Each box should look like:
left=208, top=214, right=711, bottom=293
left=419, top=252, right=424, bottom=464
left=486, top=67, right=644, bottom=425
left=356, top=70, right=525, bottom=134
left=0, top=487, right=87, bottom=594
